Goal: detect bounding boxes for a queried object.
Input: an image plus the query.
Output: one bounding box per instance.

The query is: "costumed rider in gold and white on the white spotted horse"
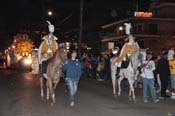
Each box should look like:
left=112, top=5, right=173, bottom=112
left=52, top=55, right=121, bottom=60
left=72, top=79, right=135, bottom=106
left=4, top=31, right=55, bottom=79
left=116, top=23, right=140, bottom=68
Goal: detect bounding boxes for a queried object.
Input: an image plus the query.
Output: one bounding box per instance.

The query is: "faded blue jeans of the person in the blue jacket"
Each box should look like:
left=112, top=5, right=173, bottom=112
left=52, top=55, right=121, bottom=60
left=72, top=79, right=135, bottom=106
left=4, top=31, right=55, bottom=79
left=66, top=78, right=78, bottom=102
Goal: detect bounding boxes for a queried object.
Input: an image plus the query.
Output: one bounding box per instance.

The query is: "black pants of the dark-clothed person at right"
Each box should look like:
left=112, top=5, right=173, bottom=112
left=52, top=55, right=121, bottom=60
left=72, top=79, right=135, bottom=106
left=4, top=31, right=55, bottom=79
left=160, top=77, right=168, bottom=97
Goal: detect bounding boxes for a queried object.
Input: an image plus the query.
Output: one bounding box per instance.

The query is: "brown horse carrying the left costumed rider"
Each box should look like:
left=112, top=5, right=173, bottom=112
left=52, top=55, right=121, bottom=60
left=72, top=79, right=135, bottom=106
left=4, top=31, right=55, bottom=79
left=40, top=46, right=68, bottom=105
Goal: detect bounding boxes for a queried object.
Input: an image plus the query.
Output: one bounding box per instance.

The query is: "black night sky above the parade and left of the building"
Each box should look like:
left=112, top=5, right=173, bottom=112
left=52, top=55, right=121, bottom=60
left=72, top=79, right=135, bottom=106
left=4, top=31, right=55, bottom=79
left=0, top=0, right=163, bottom=49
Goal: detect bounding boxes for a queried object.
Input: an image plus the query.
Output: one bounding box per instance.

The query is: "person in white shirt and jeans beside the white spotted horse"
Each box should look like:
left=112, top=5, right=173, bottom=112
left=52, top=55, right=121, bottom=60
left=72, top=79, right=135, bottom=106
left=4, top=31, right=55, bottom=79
left=141, top=53, right=159, bottom=103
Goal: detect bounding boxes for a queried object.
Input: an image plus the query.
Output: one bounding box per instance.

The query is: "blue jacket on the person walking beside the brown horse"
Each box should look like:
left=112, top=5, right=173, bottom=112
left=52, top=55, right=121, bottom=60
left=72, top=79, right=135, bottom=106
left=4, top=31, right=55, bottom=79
left=63, top=59, right=81, bottom=79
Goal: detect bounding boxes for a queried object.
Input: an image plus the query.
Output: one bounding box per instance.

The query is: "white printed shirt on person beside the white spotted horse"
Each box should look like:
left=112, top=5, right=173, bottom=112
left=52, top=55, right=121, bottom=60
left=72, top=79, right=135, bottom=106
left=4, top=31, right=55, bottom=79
left=141, top=60, right=156, bottom=79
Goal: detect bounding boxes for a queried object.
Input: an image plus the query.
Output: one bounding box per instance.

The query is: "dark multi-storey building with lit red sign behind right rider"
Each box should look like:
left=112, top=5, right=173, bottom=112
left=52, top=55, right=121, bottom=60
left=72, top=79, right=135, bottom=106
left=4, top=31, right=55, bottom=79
left=100, top=3, right=175, bottom=54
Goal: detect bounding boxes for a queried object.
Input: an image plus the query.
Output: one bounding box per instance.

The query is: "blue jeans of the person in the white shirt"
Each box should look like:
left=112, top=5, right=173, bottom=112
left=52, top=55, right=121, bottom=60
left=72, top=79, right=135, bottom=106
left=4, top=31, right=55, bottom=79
left=143, top=78, right=157, bottom=102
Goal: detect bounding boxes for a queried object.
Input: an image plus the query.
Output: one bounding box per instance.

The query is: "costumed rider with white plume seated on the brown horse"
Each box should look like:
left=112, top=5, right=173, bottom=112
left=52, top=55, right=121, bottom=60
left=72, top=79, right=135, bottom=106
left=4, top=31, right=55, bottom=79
left=38, top=21, right=58, bottom=73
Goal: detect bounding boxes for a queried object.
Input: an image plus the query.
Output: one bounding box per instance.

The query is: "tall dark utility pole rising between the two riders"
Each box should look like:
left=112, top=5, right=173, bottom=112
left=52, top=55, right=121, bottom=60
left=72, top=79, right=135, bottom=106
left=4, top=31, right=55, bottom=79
left=78, top=0, right=84, bottom=57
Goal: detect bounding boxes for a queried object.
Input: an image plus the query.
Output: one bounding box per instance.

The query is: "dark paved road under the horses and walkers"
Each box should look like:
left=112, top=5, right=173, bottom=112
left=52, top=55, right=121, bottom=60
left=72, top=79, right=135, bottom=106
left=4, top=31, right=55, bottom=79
left=0, top=70, right=175, bottom=116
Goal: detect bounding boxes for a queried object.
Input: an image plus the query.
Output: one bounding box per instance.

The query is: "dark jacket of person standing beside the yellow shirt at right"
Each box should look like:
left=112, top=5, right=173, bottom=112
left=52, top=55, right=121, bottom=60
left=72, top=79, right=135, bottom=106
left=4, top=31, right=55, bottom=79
left=157, top=58, right=170, bottom=80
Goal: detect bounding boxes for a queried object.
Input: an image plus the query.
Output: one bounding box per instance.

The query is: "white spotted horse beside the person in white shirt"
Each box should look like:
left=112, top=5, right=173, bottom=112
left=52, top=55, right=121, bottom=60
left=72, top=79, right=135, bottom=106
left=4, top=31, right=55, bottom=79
left=118, top=50, right=146, bottom=101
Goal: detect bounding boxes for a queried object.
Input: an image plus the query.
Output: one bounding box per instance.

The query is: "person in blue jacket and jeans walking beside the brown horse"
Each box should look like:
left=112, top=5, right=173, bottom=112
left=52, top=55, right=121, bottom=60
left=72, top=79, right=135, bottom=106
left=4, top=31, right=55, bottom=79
left=63, top=50, right=81, bottom=107
